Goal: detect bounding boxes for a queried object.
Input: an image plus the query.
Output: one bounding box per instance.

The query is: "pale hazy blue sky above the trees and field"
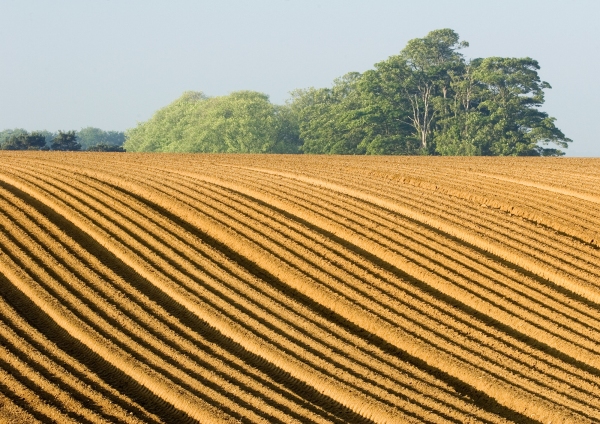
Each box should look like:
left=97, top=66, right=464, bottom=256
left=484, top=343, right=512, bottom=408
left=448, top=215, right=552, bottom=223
left=0, top=0, right=600, bottom=156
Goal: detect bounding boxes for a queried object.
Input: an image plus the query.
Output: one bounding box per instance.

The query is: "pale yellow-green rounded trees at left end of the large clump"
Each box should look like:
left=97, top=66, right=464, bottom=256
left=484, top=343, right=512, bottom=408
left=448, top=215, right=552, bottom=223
left=124, top=91, right=299, bottom=153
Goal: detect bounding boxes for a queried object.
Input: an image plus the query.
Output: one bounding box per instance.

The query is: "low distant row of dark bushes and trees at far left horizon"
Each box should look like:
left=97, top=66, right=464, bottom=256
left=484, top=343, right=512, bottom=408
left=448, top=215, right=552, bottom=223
left=0, top=127, right=125, bottom=152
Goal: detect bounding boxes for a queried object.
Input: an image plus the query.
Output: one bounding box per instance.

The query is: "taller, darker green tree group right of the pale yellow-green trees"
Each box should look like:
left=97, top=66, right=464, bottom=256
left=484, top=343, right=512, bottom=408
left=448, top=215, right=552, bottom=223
left=290, top=29, right=571, bottom=156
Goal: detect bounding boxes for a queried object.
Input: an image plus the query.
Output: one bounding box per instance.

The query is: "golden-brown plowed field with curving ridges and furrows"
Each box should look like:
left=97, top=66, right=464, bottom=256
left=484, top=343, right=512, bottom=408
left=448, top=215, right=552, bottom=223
left=0, top=152, right=600, bottom=423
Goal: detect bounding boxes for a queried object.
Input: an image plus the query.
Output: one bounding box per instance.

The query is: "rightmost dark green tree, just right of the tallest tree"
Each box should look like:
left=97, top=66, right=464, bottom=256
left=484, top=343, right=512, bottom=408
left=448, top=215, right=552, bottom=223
left=435, top=57, right=571, bottom=156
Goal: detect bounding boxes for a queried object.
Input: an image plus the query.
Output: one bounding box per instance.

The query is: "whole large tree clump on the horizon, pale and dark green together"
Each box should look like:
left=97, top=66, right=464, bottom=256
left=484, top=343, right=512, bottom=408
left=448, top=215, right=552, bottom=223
left=124, top=29, right=571, bottom=156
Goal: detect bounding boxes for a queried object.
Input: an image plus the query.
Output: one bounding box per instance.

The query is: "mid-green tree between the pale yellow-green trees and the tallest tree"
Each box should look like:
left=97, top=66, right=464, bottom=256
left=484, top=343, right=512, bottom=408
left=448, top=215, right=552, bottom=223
left=290, top=71, right=416, bottom=155
